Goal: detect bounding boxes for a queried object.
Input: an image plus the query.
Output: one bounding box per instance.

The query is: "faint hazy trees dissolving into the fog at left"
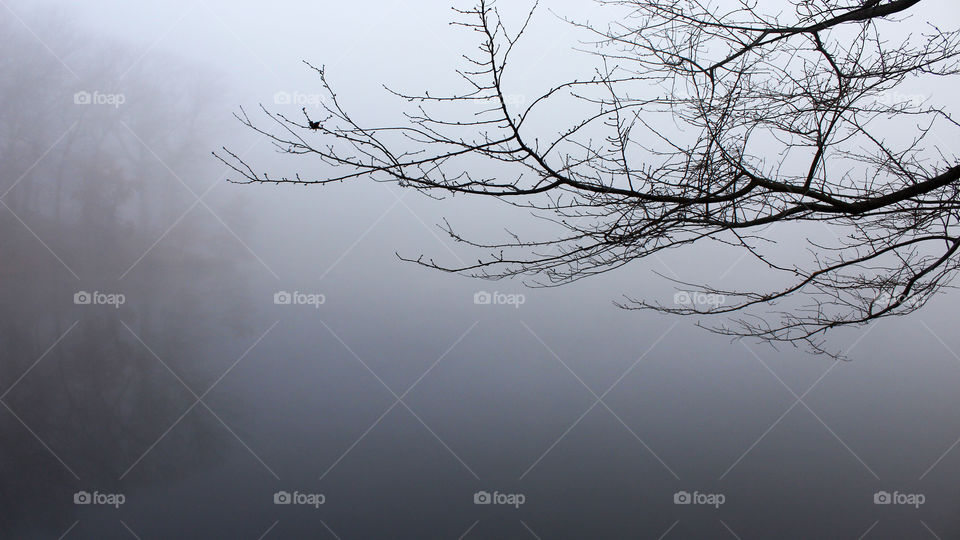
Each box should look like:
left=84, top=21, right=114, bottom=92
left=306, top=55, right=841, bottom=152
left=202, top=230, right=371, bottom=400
left=0, top=6, right=255, bottom=538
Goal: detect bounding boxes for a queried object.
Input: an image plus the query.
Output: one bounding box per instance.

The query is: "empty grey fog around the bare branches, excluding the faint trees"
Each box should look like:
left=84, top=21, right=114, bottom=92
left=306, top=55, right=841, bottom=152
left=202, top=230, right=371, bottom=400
left=0, top=0, right=960, bottom=538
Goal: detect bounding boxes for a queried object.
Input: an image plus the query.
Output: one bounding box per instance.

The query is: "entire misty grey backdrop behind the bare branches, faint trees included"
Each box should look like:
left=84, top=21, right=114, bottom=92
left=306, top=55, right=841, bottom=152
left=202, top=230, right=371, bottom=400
left=0, top=0, right=960, bottom=539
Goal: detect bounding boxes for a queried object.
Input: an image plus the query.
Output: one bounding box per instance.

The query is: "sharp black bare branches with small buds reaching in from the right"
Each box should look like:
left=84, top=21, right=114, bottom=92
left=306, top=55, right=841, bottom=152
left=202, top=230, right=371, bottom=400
left=220, top=0, right=960, bottom=352
